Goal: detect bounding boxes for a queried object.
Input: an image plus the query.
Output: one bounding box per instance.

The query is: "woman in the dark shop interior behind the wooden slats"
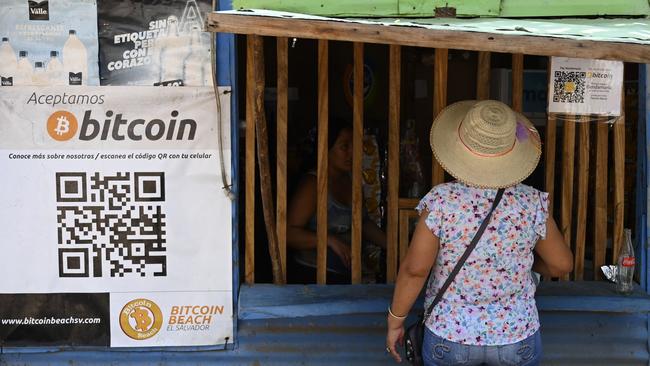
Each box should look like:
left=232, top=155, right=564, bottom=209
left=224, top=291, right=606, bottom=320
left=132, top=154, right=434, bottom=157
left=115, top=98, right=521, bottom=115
left=287, top=119, right=386, bottom=284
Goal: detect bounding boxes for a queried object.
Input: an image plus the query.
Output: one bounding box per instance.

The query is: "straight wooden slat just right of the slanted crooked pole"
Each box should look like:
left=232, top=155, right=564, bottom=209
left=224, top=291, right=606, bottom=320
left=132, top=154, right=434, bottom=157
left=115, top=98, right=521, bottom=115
left=276, top=37, right=289, bottom=282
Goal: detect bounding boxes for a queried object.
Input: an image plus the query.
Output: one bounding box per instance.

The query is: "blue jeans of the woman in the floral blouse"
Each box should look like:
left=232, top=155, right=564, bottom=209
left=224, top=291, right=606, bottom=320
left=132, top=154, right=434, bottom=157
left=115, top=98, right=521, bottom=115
left=422, top=328, right=542, bottom=366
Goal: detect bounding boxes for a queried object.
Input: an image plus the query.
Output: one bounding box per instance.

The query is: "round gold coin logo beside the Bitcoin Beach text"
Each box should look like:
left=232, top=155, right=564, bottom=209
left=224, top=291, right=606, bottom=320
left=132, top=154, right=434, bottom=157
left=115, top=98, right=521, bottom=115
left=120, top=299, right=163, bottom=340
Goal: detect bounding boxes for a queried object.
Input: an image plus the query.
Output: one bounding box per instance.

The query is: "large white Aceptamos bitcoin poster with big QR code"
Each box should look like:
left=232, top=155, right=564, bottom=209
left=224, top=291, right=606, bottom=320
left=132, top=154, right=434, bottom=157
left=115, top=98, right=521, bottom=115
left=0, top=87, right=233, bottom=347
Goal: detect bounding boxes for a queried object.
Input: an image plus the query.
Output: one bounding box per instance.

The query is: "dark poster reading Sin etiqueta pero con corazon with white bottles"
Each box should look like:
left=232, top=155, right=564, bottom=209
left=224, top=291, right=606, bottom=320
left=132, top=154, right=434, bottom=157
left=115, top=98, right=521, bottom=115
left=98, top=0, right=212, bottom=86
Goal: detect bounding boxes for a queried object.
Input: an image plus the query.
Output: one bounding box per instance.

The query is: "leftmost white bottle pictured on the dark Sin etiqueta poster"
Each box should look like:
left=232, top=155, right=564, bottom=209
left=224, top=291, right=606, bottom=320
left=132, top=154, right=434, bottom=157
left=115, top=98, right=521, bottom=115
left=160, top=15, right=189, bottom=86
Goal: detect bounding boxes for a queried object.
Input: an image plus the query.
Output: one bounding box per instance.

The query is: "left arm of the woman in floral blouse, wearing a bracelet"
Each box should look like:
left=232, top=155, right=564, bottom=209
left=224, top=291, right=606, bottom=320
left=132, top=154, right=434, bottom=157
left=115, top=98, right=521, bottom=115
left=386, top=211, right=440, bottom=362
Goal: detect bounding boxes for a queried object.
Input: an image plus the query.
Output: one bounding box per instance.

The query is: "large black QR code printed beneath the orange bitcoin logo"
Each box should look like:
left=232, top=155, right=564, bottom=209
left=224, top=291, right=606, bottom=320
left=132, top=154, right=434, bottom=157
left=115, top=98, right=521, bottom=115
left=56, top=172, right=167, bottom=277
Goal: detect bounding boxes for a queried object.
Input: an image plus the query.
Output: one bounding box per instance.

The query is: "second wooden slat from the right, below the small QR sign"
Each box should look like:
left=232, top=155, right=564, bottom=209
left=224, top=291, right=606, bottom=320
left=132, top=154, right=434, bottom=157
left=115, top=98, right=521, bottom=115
left=593, top=119, right=609, bottom=279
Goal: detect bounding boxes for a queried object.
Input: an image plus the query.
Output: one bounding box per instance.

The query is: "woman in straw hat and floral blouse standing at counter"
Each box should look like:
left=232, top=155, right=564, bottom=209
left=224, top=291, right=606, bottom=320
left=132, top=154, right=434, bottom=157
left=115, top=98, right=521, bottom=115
left=386, top=101, right=573, bottom=365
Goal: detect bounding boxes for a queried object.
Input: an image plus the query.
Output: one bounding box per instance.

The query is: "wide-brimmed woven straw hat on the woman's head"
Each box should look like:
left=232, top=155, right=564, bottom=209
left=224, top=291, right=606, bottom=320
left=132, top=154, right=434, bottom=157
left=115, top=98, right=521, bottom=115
left=430, top=100, right=542, bottom=188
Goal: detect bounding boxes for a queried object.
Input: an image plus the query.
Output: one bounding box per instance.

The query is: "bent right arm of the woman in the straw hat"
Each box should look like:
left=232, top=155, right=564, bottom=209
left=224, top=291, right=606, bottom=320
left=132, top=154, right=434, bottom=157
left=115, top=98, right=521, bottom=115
left=533, top=215, right=573, bottom=277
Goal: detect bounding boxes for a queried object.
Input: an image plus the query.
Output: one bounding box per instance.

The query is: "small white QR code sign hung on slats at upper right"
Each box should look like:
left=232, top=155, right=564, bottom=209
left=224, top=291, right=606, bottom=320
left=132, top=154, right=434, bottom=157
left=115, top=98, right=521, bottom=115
left=548, top=57, right=623, bottom=116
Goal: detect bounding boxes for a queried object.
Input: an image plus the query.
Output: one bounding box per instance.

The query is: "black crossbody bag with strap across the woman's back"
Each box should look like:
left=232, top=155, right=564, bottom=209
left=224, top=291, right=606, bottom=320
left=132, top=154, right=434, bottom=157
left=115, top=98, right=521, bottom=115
left=404, top=188, right=505, bottom=366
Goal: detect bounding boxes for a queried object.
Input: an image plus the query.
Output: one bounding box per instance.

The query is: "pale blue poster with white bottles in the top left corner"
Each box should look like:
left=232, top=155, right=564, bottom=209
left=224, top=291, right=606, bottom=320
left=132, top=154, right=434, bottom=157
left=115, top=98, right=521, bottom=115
left=0, top=0, right=99, bottom=86
